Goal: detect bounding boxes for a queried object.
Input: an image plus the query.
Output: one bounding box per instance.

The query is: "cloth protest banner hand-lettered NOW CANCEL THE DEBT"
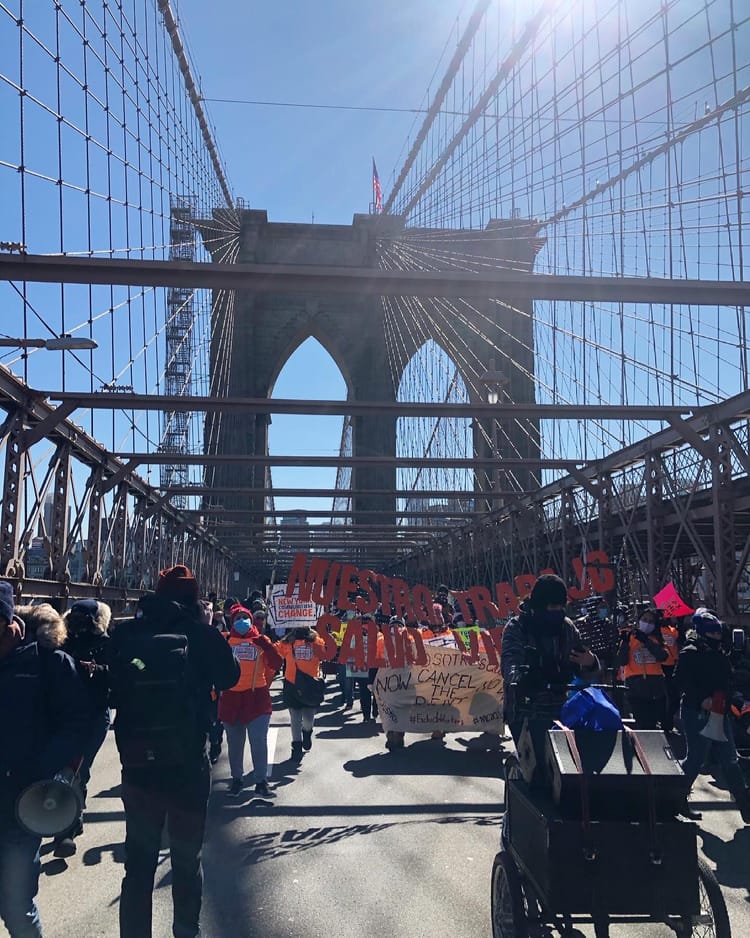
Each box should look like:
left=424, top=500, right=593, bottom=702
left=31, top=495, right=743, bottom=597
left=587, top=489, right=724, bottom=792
left=373, top=642, right=503, bottom=733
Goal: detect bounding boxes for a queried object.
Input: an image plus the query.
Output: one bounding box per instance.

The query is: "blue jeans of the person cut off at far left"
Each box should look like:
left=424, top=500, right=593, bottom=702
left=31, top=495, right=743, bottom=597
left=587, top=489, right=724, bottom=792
left=0, top=823, right=42, bottom=938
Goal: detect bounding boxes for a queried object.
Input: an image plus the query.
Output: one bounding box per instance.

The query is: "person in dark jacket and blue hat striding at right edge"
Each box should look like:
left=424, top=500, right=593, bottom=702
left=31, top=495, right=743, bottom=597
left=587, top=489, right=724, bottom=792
left=675, top=608, right=750, bottom=824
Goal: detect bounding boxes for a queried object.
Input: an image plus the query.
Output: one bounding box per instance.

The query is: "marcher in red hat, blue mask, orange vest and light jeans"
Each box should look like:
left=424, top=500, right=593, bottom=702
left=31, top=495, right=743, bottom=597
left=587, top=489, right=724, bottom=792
left=219, top=605, right=281, bottom=797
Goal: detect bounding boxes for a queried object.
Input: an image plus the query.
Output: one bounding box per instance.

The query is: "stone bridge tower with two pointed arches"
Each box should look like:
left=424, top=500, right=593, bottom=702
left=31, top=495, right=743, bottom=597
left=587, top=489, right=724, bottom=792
left=199, top=209, right=541, bottom=568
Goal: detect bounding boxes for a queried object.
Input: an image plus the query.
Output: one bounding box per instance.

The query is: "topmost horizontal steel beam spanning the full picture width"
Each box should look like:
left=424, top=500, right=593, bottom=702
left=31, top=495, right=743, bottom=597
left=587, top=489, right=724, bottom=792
left=0, top=254, right=750, bottom=306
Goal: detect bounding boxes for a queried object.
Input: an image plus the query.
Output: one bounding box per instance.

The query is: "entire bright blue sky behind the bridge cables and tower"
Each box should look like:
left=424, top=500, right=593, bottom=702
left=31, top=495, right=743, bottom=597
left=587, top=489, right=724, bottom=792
left=0, top=0, right=750, bottom=524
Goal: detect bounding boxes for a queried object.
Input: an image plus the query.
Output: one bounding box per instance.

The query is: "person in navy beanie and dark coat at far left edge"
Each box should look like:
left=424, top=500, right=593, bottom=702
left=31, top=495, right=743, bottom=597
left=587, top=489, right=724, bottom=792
left=0, top=581, right=92, bottom=938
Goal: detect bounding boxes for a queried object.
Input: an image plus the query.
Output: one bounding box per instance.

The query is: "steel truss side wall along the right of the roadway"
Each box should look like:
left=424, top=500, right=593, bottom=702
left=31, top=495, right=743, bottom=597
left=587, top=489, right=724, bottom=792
left=392, top=391, right=750, bottom=625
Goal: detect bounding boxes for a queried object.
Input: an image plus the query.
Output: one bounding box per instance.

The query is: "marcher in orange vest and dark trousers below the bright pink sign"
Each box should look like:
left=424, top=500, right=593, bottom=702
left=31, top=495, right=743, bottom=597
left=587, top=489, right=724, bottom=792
left=615, top=609, right=669, bottom=730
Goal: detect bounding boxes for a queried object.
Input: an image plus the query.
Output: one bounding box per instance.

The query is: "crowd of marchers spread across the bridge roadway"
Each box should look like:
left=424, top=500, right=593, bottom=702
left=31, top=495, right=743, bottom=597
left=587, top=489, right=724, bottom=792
left=0, top=565, right=750, bottom=938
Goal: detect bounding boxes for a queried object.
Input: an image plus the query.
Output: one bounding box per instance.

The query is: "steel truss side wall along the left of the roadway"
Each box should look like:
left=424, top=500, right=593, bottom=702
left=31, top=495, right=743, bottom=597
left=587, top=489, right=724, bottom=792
left=0, top=367, right=230, bottom=602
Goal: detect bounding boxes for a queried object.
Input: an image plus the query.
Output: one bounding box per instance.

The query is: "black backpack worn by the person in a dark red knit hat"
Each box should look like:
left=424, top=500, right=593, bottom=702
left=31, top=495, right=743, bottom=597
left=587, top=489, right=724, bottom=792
left=110, top=619, right=200, bottom=768
